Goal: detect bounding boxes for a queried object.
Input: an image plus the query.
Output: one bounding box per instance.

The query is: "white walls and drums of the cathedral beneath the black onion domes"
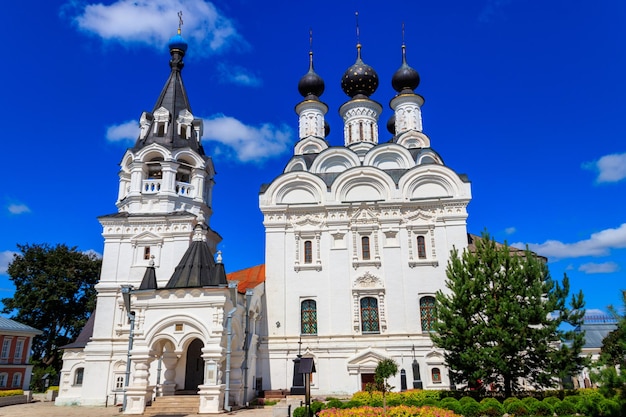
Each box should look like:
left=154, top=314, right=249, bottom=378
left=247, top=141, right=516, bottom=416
left=259, top=44, right=471, bottom=396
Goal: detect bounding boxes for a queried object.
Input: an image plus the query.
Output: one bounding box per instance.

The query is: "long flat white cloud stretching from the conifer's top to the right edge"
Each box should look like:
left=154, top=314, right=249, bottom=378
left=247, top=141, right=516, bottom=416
left=511, top=223, right=626, bottom=259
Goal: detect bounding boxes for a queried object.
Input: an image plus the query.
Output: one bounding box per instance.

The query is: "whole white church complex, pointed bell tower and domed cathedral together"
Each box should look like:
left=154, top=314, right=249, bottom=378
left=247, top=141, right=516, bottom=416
left=56, top=26, right=471, bottom=414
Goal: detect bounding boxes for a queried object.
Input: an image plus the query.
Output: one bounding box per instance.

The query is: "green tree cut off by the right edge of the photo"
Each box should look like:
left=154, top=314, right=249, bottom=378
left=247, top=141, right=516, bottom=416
left=593, top=290, right=626, bottom=406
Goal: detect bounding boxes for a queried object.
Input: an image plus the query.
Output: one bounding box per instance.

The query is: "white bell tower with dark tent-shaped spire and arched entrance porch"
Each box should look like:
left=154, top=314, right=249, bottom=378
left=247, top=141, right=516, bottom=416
left=56, top=31, right=263, bottom=414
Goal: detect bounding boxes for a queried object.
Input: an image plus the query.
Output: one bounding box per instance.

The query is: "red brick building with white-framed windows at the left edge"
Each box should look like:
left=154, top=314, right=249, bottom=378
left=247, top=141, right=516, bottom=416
left=0, top=317, right=42, bottom=390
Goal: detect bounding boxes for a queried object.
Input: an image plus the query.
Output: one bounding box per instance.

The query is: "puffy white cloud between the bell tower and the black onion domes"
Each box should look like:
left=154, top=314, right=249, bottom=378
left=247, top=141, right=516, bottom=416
left=204, top=114, right=292, bottom=162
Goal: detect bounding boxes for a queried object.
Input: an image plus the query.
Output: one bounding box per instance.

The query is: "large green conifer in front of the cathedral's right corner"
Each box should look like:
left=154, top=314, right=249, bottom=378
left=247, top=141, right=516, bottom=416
left=431, top=232, right=585, bottom=397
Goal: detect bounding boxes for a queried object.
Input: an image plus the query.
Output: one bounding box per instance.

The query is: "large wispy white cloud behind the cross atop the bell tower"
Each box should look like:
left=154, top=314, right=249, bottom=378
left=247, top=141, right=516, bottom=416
left=73, top=0, right=245, bottom=56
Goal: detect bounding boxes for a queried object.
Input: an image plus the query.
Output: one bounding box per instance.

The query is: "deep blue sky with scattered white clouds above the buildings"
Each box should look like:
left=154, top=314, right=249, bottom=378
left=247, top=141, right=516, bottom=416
left=0, top=0, right=626, bottom=310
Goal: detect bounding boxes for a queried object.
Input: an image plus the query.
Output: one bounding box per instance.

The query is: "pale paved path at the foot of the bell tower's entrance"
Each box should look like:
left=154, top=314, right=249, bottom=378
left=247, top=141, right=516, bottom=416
left=0, top=402, right=273, bottom=417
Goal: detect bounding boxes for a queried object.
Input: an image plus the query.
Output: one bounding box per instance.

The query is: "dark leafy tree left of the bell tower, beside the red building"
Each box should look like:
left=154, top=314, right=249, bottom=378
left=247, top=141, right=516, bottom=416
left=2, top=240, right=101, bottom=372
